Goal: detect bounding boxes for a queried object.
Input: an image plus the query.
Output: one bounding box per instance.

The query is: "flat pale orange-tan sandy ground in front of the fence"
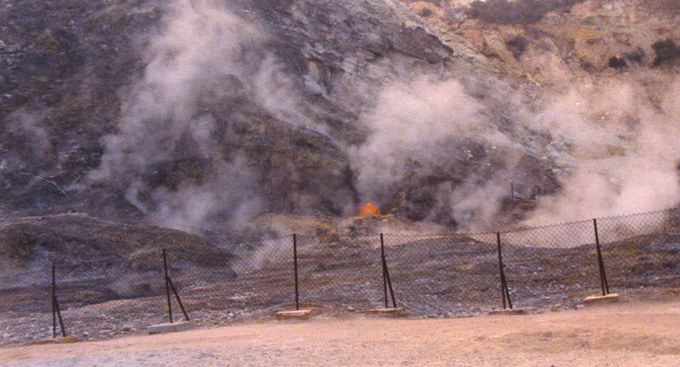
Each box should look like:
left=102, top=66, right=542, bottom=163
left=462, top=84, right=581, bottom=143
left=0, top=297, right=680, bottom=367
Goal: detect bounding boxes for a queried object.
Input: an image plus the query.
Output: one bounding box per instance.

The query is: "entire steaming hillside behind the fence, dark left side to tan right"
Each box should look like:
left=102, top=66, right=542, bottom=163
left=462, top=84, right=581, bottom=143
left=0, top=0, right=680, bottom=237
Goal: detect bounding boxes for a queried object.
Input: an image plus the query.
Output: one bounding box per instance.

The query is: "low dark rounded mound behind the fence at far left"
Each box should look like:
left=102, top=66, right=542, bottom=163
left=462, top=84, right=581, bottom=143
left=0, top=213, right=233, bottom=274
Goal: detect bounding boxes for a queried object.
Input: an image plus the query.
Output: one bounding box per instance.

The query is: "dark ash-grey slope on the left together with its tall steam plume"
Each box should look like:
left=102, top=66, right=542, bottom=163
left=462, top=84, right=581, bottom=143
left=0, top=0, right=532, bottom=229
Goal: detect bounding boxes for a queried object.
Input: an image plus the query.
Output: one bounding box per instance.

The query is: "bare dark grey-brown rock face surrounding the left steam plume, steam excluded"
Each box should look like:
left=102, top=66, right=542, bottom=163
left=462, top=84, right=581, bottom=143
left=0, top=1, right=500, bottom=230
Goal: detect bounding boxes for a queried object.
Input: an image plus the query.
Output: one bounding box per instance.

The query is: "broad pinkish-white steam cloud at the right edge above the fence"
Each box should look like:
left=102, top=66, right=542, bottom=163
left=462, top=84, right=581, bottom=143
left=530, top=81, right=680, bottom=224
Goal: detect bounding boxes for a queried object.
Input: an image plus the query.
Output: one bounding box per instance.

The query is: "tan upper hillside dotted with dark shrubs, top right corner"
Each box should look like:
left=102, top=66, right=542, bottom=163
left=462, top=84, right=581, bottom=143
left=409, top=0, right=680, bottom=88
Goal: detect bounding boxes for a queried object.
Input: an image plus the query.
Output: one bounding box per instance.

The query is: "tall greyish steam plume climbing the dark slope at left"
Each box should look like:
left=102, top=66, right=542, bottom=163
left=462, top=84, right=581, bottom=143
left=91, top=0, right=306, bottom=230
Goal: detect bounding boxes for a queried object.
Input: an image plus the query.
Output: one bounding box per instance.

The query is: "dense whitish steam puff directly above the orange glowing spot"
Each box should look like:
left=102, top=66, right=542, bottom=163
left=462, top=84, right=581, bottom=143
left=354, top=79, right=484, bottom=198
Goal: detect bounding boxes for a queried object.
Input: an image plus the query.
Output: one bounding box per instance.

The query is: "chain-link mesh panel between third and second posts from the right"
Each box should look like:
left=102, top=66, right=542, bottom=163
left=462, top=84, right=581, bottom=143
left=385, top=234, right=500, bottom=316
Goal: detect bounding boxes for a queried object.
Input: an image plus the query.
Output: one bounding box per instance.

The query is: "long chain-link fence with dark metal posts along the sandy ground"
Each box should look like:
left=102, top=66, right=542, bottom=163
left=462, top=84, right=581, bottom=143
left=0, top=209, right=680, bottom=345
